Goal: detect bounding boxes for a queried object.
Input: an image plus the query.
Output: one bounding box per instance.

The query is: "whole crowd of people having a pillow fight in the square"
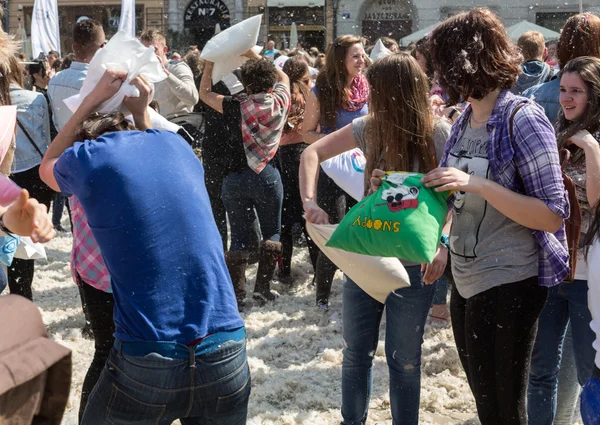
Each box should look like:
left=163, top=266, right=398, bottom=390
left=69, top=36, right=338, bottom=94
left=0, top=4, right=600, bottom=425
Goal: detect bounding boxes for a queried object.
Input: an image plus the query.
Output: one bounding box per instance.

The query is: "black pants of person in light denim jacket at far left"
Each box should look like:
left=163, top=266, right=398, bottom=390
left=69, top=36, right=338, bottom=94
left=7, top=165, right=55, bottom=300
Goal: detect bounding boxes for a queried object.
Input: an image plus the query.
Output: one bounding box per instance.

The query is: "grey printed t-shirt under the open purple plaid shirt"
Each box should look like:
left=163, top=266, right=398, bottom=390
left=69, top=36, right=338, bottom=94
left=447, top=121, right=538, bottom=298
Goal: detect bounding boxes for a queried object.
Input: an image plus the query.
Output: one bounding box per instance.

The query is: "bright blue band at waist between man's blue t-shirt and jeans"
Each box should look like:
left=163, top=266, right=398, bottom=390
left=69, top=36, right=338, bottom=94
left=114, top=327, right=246, bottom=359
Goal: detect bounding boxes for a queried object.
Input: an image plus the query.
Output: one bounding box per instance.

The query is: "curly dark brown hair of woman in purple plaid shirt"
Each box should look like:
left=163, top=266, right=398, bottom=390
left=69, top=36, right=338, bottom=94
left=429, top=8, right=523, bottom=105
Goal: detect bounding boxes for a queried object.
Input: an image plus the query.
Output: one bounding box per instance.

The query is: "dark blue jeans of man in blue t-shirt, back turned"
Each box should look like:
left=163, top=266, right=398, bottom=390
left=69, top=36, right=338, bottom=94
left=81, top=340, right=251, bottom=425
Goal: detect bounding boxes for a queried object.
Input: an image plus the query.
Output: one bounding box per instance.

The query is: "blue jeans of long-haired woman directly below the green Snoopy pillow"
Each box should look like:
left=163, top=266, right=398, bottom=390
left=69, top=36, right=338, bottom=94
left=342, top=266, right=437, bottom=425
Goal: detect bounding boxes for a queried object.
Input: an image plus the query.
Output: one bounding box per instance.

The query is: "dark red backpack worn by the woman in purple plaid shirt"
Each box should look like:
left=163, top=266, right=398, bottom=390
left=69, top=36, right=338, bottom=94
left=510, top=102, right=582, bottom=282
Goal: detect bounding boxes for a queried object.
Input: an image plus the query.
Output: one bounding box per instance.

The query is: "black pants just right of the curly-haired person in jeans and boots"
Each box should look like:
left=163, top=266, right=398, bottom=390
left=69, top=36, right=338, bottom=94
left=278, top=143, right=319, bottom=276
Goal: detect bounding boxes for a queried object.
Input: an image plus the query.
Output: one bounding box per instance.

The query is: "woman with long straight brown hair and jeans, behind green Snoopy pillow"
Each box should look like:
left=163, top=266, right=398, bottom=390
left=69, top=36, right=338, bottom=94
left=300, top=53, right=448, bottom=425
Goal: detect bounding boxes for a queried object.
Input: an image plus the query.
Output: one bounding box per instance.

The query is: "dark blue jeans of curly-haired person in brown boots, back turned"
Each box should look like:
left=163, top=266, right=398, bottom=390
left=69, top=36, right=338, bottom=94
left=221, top=164, right=283, bottom=251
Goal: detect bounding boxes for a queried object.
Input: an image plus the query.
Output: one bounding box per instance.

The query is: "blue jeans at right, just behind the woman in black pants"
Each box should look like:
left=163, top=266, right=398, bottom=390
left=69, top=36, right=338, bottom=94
left=527, top=280, right=595, bottom=425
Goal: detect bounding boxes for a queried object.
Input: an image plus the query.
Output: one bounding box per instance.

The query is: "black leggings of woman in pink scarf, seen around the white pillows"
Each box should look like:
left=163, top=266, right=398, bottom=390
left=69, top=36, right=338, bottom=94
left=310, top=167, right=356, bottom=304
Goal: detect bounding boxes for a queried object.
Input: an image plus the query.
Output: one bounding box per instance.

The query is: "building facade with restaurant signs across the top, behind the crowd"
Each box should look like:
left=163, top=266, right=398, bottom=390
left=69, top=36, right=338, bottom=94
left=0, top=0, right=600, bottom=56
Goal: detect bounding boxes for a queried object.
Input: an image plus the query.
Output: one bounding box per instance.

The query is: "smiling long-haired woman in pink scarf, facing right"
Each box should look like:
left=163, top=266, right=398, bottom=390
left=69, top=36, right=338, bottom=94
left=302, top=35, right=369, bottom=311
